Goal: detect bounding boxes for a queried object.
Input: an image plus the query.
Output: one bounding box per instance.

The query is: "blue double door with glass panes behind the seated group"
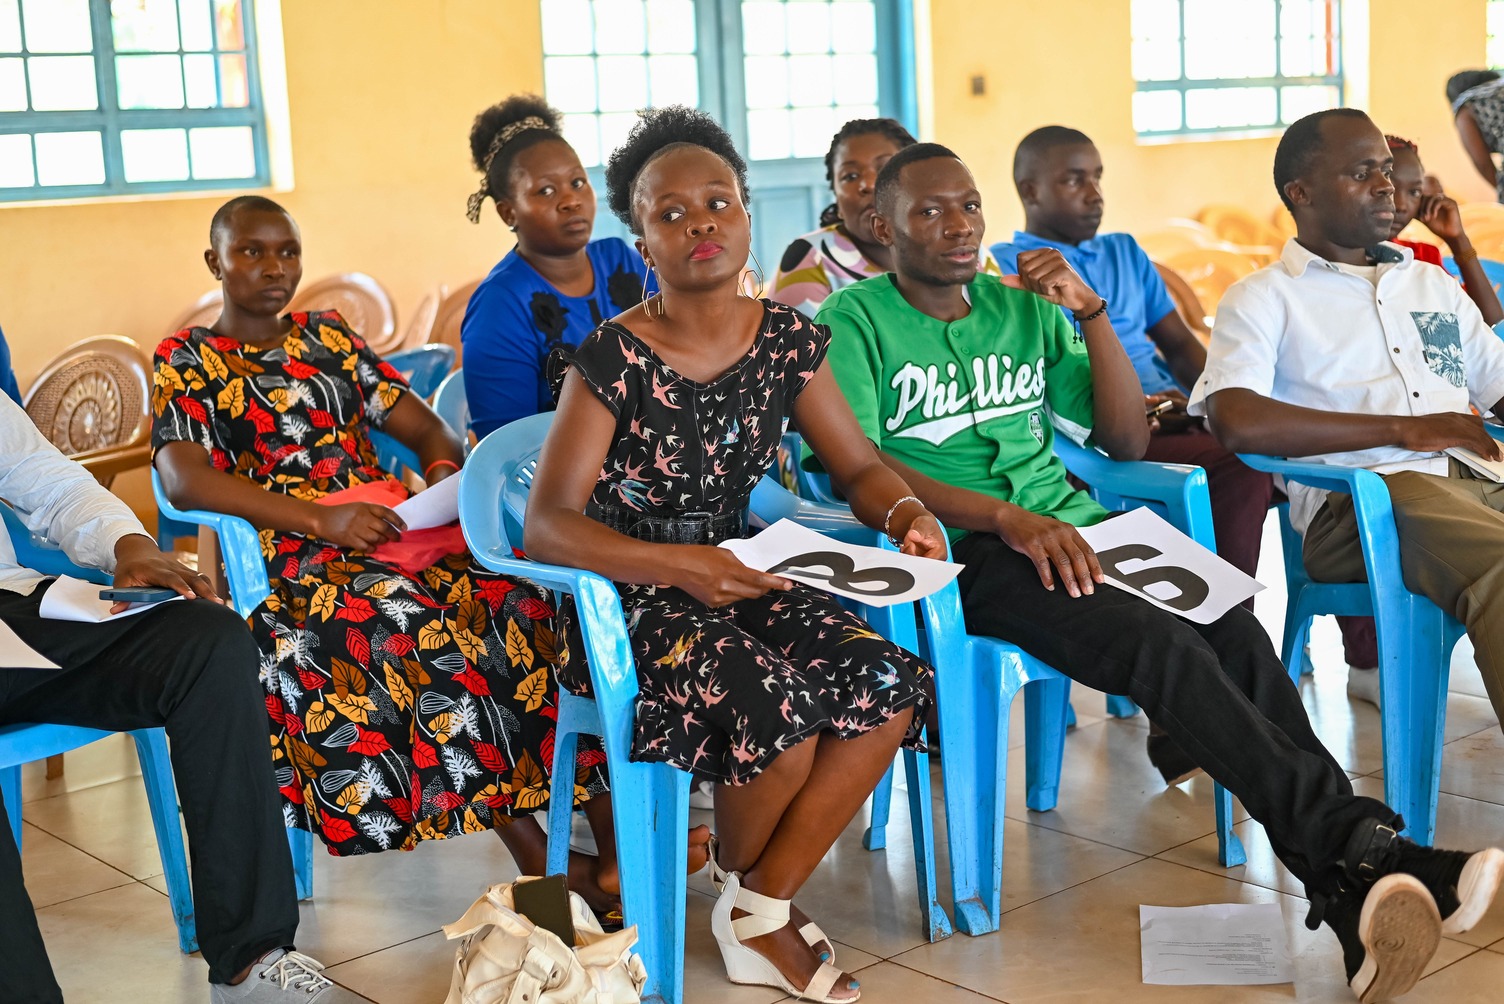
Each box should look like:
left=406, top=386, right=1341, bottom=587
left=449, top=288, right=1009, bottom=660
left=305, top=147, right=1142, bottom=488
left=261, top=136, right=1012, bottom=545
left=540, top=0, right=917, bottom=278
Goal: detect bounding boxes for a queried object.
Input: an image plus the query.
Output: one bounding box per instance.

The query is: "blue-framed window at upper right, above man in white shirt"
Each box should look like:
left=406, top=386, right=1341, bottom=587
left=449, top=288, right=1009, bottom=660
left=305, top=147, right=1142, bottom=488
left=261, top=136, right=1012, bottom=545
left=1133, top=0, right=1343, bottom=138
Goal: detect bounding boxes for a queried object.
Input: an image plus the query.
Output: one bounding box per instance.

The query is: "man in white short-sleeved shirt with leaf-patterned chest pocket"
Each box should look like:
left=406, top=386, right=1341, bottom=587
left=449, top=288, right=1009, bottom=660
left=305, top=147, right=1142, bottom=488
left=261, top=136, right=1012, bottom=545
left=1191, top=108, right=1504, bottom=736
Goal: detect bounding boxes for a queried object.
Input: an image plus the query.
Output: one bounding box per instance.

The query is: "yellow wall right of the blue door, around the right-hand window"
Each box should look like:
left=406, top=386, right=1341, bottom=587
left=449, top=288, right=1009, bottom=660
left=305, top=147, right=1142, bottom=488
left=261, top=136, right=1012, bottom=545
left=929, top=0, right=1492, bottom=240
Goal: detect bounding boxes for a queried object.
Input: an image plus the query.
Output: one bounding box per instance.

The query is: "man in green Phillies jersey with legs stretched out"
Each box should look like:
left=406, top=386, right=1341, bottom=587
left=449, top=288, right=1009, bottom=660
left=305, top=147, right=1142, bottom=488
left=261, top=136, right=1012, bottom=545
left=818, top=143, right=1504, bottom=1001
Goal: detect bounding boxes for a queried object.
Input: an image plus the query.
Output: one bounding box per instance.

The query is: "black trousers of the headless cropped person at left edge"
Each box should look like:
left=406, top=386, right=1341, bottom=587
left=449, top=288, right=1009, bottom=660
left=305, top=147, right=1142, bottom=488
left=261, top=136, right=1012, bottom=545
left=0, top=586, right=298, bottom=1004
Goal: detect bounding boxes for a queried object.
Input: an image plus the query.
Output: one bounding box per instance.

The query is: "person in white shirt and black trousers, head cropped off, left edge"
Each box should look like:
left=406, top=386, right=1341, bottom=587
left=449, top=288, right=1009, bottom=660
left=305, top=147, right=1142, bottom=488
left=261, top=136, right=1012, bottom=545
left=0, top=394, right=361, bottom=1004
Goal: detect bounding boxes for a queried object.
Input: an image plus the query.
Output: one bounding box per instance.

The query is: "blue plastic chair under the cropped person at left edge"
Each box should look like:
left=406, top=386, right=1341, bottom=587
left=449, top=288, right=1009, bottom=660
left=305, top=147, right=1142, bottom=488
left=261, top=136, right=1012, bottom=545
left=0, top=504, right=199, bottom=953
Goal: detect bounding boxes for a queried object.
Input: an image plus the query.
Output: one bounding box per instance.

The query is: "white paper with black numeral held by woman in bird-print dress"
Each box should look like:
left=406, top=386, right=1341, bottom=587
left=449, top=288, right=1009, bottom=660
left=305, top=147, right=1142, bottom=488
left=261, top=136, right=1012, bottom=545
left=722, top=520, right=963, bottom=607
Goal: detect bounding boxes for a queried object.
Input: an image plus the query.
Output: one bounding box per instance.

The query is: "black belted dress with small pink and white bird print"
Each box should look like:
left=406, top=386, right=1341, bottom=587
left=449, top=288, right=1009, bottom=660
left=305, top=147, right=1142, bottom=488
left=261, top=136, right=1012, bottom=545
left=559, top=301, right=931, bottom=785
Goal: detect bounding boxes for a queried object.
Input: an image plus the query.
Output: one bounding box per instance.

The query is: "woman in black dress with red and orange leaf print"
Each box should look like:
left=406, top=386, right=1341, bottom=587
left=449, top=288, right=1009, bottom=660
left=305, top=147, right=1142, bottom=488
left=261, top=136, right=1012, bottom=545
left=152, top=197, right=615, bottom=909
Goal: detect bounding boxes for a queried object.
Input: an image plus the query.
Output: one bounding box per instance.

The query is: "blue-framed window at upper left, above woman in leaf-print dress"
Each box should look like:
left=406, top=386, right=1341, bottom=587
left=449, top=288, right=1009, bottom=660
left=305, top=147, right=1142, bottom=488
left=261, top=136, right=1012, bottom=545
left=0, top=0, right=271, bottom=201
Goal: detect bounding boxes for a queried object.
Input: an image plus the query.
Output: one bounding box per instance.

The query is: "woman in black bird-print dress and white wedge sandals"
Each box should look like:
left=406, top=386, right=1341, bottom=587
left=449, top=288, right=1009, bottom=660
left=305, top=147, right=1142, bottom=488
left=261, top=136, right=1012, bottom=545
left=525, top=107, right=945, bottom=1001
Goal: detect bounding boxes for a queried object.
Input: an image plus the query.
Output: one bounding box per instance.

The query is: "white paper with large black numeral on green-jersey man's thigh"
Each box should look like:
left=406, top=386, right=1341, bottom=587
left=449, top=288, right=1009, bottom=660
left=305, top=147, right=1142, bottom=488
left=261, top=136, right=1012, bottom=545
left=1080, top=508, right=1263, bottom=624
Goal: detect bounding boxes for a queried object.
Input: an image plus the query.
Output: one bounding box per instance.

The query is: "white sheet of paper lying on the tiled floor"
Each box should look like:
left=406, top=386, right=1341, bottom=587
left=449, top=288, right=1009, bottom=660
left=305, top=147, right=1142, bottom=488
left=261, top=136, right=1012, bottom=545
left=1139, top=903, right=1295, bottom=986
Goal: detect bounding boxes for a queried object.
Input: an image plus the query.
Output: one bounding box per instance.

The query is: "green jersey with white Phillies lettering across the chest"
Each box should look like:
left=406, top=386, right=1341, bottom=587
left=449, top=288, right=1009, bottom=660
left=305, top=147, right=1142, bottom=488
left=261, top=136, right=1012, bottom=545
left=817, top=275, right=1105, bottom=538
